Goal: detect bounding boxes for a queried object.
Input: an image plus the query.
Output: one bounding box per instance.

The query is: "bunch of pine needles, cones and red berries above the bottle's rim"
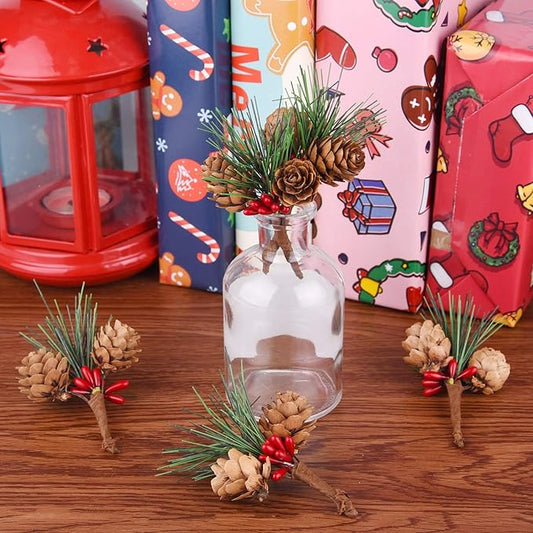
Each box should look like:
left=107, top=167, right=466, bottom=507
left=202, top=69, right=382, bottom=215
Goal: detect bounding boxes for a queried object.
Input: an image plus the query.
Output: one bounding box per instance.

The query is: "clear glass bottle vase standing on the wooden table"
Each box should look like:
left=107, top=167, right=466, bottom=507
left=223, top=202, right=344, bottom=419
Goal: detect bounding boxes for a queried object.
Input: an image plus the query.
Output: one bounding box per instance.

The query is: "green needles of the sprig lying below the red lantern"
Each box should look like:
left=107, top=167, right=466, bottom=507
left=19, top=280, right=98, bottom=377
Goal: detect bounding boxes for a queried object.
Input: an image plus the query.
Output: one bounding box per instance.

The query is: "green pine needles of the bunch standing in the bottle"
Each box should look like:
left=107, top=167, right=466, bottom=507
left=201, top=68, right=383, bottom=198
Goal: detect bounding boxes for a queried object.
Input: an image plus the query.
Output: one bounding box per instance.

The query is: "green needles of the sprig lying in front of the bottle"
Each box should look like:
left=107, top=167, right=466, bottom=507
left=158, top=369, right=265, bottom=481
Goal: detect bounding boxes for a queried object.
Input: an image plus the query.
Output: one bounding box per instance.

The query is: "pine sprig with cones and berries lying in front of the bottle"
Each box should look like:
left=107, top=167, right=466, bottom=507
left=158, top=369, right=357, bottom=518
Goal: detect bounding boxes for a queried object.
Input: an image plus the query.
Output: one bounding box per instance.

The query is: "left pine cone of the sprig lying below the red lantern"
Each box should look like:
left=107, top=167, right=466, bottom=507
left=17, top=348, right=70, bottom=402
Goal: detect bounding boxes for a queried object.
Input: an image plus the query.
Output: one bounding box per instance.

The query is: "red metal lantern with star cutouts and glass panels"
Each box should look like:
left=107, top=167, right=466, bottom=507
left=0, top=0, right=157, bottom=285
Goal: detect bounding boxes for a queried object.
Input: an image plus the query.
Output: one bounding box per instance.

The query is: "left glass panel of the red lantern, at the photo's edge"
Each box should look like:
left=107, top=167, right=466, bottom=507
left=0, top=103, right=74, bottom=242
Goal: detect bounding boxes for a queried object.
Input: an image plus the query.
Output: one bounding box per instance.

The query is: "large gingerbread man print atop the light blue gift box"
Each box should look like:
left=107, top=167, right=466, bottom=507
left=243, top=0, right=313, bottom=75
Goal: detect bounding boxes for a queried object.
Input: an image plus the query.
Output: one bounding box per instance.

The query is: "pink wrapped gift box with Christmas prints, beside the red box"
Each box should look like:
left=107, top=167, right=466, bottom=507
left=315, top=0, right=488, bottom=311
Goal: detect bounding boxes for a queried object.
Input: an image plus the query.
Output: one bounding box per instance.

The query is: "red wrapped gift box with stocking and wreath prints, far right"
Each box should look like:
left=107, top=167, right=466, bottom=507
left=428, top=0, right=533, bottom=326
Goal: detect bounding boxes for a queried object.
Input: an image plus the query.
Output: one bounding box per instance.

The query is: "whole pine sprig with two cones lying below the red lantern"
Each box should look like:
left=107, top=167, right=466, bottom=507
left=17, top=282, right=140, bottom=453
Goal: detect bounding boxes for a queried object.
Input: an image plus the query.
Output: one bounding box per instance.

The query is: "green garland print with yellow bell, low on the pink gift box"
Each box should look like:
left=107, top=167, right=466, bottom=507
left=353, top=258, right=426, bottom=304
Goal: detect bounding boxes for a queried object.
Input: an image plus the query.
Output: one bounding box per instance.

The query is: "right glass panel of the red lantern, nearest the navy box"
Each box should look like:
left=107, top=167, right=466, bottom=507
left=92, top=90, right=155, bottom=236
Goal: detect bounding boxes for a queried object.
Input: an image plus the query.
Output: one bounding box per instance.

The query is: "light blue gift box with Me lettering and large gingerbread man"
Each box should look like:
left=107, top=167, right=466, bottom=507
left=231, top=0, right=314, bottom=250
